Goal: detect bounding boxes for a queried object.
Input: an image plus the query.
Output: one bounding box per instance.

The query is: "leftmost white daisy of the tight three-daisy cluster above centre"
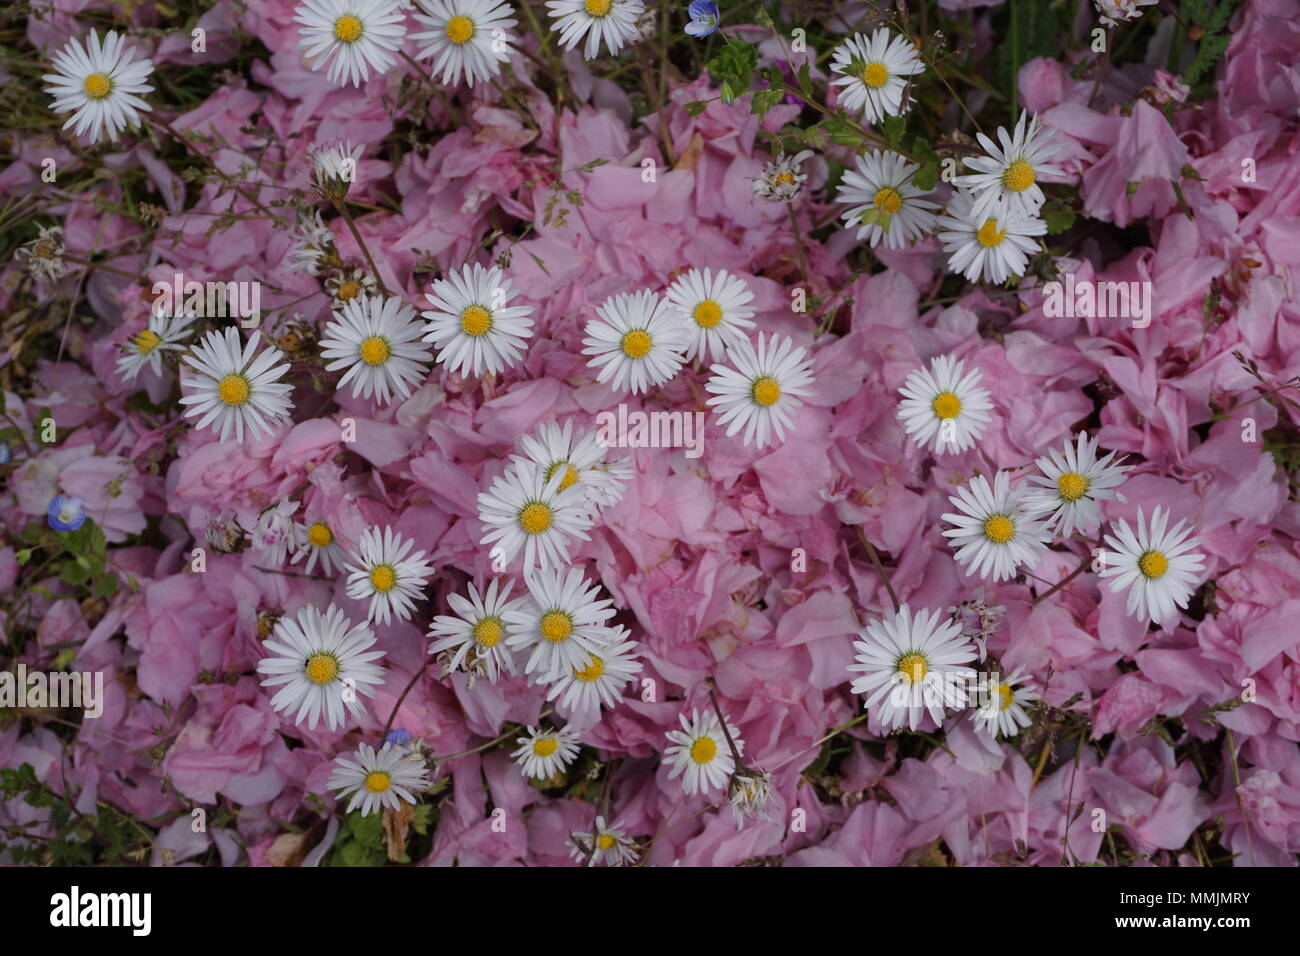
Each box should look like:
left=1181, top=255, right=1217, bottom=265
left=582, top=289, right=689, bottom=394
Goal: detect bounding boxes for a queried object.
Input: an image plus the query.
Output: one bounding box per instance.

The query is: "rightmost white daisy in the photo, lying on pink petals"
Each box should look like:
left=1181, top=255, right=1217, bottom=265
left=1100, top=506, right=1205, bottom=624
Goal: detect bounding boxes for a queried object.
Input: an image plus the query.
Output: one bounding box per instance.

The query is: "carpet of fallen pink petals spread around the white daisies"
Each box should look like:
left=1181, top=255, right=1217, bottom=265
left=0, top=0, right=1300, bottom=866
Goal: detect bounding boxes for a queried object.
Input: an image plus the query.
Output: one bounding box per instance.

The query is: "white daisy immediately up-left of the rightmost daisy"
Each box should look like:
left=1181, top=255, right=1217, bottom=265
left=1024, top=432, right=1128, bottom=536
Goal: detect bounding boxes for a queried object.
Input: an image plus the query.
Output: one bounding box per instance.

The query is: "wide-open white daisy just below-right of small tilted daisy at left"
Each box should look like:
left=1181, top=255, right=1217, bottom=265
left=181, top=328, right=294, bottom=441
